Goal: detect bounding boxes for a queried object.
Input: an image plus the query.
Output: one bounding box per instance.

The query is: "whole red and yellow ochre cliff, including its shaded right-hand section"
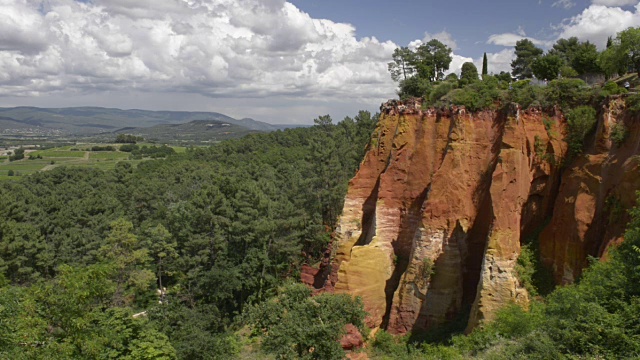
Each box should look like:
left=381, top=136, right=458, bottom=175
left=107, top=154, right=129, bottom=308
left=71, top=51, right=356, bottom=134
left=316, top=99, right=640, bottom=334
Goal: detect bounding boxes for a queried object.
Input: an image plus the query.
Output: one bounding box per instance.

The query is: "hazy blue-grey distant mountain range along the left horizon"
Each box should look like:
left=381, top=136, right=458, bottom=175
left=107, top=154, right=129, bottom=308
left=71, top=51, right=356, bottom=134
left=0, top=107, right=303, bottom=137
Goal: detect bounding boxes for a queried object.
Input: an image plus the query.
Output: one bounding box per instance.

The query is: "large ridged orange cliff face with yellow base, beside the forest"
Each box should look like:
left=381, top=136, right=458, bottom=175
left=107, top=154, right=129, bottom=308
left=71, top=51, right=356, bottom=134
left=320, top=100, right=566, bottom=333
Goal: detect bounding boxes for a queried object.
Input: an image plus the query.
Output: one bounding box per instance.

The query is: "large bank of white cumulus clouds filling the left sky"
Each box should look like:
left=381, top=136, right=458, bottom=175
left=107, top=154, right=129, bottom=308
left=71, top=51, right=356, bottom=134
left=0, top=0, right=400, bottom=121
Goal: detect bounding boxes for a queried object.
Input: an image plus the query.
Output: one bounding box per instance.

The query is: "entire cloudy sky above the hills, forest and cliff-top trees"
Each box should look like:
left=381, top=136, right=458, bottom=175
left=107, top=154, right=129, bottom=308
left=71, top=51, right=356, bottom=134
left=0, top=0, right=640, bottom=124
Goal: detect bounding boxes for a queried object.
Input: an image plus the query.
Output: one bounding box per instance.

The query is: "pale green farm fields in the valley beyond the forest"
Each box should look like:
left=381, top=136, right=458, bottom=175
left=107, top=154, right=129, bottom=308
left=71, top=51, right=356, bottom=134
left=0, top=144, right=186, bottom=181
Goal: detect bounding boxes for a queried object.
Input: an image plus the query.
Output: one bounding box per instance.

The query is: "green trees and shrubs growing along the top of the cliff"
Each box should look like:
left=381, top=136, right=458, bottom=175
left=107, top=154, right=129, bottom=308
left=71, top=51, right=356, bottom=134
left=389, top=28, right=640, bottom=111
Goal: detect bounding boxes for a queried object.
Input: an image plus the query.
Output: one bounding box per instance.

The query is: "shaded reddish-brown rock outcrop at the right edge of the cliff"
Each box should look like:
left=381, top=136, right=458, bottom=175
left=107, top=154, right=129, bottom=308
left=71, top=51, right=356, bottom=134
left=540, top=98, right=640, bottom=284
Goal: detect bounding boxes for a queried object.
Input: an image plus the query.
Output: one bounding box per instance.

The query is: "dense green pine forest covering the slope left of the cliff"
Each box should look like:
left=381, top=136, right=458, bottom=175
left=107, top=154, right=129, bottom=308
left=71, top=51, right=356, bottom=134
left=0, top=111, right=376, bottom=359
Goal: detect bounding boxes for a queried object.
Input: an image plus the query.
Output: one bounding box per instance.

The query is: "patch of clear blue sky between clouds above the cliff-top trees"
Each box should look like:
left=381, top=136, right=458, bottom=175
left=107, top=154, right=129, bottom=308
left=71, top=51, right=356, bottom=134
left=291, top=0, right=591, bottom=57
